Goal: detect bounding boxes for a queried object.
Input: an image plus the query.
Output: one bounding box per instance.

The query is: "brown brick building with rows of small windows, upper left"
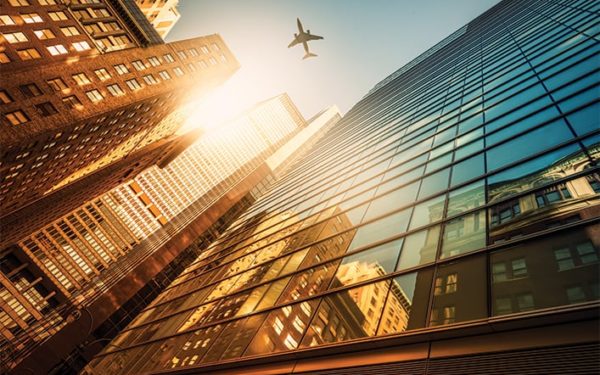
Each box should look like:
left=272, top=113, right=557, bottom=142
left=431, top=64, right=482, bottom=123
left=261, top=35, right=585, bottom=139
left=0, top=0, right=239, bottom=247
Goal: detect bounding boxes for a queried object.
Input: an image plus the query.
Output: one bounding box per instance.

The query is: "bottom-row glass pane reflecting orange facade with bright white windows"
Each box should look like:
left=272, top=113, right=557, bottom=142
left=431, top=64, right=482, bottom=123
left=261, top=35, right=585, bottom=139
left=244, top=300, right=319, bottom=355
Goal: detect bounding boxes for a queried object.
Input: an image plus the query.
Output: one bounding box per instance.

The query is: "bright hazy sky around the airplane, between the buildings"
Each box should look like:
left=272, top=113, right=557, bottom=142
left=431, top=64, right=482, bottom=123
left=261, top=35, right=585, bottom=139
left=166, top=0, right=499, bottom=128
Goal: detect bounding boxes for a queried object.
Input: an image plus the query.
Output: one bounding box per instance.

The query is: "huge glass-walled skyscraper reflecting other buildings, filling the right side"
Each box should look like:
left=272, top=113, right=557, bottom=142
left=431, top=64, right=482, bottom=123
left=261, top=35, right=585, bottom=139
left=88, top=0, right=600, bottom=374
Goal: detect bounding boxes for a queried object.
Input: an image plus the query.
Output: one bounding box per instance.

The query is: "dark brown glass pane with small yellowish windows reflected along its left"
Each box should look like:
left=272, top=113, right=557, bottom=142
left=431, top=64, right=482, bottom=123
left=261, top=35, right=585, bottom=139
left=429, top=255, right=487, bottom=326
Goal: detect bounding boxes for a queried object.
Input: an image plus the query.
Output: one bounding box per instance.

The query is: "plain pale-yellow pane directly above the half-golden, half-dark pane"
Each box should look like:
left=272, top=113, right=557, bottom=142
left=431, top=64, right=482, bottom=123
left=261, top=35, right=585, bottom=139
left=396, top=225, right=440, bottom=271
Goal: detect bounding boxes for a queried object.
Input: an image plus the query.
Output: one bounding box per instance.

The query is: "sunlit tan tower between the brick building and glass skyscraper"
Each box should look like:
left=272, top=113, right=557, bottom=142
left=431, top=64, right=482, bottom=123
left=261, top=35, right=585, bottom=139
left=0, top=94, right=340, bottom=373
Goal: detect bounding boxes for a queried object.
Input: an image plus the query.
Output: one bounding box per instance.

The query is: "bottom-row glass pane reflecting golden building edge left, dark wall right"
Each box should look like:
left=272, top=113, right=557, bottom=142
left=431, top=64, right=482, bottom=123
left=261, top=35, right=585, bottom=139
left=377, top=268, right=433, bottom=335
